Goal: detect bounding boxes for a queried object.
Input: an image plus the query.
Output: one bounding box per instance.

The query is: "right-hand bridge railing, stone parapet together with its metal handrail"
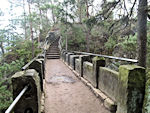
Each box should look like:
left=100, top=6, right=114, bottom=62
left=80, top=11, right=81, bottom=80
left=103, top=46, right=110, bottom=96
left=61, top=50, right=146, bottom=113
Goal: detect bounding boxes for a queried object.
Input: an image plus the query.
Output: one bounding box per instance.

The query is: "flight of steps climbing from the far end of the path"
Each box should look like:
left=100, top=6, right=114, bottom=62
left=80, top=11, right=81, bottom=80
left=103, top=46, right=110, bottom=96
left=46, top=39, right=60, bottom=59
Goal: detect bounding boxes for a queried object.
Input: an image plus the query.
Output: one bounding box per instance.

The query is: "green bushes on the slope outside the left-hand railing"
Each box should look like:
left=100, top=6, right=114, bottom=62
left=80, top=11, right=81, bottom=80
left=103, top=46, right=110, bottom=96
left=0, top=39, right=41, bottom=110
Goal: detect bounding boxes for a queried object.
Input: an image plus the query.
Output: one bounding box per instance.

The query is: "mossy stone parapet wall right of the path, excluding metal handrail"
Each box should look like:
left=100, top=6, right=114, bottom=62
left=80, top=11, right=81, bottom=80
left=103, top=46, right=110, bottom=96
left=61, top=52, right=146, bottom=113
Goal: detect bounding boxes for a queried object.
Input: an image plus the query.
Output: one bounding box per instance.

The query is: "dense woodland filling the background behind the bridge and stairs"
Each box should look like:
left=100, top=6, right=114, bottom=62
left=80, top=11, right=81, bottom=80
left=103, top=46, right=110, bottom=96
left=0, top=0, right=150, bottom=112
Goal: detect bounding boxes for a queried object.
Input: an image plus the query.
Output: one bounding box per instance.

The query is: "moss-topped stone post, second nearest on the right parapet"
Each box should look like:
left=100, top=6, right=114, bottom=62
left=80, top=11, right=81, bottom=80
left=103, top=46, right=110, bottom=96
left=92, top=57, right=105, bottom=88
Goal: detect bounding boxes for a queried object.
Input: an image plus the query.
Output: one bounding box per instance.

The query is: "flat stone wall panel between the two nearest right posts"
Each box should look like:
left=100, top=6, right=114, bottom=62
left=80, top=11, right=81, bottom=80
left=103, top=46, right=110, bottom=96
left=98, top=67, right=119, bottom=101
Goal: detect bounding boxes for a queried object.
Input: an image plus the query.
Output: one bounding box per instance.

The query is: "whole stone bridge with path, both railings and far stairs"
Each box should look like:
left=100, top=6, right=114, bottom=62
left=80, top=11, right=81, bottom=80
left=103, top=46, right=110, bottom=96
left=6, top=32, right=150, bottom=113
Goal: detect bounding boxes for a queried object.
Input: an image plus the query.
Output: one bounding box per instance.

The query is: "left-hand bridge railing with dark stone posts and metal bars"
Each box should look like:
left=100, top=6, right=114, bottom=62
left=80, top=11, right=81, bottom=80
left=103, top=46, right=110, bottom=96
left=5, top=53, right=45, bottom=113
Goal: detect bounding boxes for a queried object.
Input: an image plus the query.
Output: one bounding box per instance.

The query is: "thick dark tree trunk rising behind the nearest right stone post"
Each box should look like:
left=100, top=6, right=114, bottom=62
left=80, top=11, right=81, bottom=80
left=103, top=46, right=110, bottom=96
left=137, top=0, right=147, bottom=67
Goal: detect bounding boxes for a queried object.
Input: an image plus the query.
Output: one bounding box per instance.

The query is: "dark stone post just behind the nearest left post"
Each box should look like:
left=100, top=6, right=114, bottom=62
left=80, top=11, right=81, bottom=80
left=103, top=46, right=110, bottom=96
left=28, top=59, right=43, bottom=91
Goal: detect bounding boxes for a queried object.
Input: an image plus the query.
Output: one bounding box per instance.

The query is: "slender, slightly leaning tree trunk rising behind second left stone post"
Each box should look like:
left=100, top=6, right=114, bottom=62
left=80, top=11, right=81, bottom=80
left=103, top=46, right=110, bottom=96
left=28, top=2, right=34, bottom=58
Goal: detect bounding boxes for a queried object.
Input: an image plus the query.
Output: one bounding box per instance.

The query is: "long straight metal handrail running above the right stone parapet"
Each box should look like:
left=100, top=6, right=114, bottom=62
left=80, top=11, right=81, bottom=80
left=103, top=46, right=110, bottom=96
left=73, top=51, right=138, bottom=63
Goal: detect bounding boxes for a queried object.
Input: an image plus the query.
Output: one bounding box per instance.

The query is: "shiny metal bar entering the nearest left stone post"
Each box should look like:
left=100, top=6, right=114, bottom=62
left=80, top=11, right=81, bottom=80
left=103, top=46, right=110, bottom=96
left=5, top=85, right=28, bottom=113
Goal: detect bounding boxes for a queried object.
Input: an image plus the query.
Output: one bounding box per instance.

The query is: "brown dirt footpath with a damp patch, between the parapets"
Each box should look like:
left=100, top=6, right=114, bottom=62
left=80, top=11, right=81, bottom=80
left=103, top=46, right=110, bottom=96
left=44, top=59, right=109, bottom=113
